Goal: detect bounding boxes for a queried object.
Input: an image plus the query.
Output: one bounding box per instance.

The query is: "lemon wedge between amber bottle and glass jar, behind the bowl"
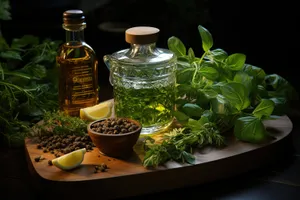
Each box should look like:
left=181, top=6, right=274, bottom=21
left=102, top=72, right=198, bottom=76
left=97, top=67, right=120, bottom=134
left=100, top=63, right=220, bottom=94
left=80, top=101, right=113, bottom=121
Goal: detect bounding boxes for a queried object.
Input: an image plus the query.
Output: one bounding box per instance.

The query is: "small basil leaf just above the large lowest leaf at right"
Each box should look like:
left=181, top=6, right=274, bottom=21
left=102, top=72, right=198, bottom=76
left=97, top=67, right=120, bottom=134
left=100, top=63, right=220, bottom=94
left=252, top=99, right=275, bottom=119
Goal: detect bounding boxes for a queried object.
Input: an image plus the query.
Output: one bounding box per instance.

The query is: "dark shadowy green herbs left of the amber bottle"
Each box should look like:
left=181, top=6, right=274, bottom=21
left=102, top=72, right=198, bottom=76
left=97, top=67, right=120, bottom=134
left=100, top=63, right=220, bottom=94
left=0, top=0, right=61, bottom=145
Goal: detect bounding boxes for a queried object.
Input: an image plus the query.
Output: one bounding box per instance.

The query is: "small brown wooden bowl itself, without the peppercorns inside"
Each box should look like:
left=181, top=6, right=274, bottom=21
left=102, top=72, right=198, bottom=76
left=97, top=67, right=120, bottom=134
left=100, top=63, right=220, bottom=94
left=87, top=118, right=142, bottom=158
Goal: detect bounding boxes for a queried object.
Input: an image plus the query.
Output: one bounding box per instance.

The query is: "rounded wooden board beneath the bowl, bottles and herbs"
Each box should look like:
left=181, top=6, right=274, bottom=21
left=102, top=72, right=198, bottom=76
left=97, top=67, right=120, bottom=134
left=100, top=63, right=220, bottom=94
left=25, top=116, right=293, bottom=199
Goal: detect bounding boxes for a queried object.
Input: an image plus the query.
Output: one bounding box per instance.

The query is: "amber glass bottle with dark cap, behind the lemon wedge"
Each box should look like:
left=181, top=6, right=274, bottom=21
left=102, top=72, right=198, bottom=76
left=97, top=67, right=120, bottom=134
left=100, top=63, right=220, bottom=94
left=56, top=10, right=99, bottom=117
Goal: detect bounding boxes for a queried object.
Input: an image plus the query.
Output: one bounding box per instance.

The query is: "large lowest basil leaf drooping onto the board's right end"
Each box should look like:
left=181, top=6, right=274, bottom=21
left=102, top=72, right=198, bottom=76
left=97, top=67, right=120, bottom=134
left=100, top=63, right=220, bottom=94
left=234, top=116, right=270, bottom=143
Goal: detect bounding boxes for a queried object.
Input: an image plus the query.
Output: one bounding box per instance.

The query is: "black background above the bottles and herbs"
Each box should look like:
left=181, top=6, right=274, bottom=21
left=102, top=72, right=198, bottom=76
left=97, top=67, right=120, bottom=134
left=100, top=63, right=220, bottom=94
left=2, top=0, right=299, bottom=91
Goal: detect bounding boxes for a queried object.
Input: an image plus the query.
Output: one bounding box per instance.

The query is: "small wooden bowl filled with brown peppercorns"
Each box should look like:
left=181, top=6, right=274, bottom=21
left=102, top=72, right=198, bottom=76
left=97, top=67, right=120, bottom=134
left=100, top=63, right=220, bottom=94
left=87, top=117, right=142, bottom=158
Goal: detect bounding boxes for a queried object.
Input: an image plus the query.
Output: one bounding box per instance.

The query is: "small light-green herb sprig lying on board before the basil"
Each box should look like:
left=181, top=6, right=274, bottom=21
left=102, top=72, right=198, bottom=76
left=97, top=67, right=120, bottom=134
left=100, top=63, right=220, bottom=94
left=143, top=117, right=225, bottom=167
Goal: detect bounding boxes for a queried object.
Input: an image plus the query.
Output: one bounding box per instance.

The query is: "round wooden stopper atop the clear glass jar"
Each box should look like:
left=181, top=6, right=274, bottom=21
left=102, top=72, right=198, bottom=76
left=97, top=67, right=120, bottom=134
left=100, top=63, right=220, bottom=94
left=125, top=26, right=159, bottom=44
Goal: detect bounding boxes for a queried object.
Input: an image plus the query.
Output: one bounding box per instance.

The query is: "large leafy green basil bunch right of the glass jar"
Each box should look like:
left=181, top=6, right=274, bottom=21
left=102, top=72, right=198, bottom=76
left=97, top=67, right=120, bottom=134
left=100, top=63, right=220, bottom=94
left=168, top=25, right=298, bottom=143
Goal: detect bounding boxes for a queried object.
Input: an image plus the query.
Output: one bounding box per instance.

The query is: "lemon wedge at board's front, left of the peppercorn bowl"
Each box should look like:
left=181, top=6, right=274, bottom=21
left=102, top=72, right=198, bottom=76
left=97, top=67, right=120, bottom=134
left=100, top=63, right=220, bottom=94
left=52, top=148, right=86, bottom=170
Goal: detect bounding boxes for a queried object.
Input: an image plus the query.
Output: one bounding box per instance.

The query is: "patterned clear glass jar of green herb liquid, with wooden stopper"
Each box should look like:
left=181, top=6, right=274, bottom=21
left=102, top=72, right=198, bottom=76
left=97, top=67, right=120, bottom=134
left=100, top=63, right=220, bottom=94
left=104, top=27, right=177, bottom=134
